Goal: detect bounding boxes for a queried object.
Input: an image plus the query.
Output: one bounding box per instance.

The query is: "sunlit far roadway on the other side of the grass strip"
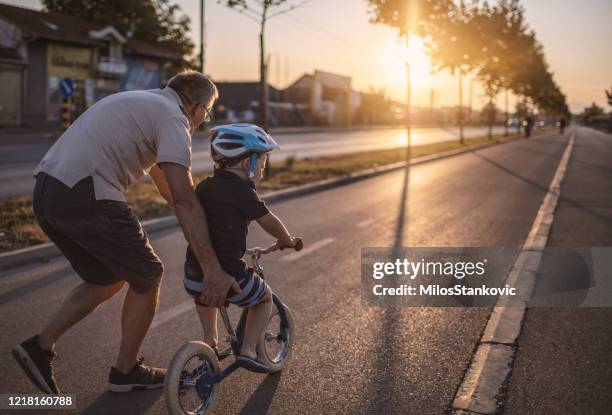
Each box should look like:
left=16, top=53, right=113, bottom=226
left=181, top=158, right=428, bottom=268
left=0, top=127, right=503, bottom=199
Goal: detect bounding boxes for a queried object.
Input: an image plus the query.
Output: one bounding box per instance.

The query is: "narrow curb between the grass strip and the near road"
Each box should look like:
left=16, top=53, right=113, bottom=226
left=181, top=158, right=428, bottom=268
left=0, top=136, right=544, bottom=271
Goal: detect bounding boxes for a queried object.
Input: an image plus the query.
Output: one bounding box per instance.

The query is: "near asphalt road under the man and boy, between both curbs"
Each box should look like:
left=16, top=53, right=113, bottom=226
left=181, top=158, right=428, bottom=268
left=0, top=128, right=568, bottom=414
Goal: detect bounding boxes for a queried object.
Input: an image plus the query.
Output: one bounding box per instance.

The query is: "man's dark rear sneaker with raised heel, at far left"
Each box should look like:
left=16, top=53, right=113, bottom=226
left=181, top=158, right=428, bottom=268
left=13, top=335, right=60, bottom=395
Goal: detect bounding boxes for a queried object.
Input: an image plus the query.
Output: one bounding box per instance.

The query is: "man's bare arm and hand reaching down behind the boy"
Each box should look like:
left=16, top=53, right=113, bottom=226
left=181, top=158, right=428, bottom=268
left=160, top=163, right=240, bottom=307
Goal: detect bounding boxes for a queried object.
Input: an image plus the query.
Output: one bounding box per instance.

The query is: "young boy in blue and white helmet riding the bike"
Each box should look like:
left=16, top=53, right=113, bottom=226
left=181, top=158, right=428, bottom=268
left=184, top=124, right=296, bottom=372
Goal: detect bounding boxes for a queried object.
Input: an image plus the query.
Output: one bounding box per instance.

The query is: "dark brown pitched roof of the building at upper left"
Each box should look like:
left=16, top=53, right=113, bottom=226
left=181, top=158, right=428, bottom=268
left=0, top=3, right=180, bottom=59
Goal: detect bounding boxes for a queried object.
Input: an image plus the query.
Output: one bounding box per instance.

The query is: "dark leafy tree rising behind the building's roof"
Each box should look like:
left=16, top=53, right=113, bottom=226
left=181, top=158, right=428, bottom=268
left=42, top=0, right=194, bottom=74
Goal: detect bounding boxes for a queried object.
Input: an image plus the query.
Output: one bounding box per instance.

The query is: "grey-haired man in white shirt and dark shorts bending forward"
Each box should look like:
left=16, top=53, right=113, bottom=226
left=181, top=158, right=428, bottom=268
left=13, top=71, right=239, bottom=394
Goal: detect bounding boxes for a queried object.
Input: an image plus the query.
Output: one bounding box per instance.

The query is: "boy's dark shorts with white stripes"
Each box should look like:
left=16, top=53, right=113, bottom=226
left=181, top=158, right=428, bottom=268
left=183, top=268, right=268, bottom=307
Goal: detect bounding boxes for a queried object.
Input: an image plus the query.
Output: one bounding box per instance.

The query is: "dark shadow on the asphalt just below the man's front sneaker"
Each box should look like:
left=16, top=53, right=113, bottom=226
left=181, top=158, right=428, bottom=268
left=81, top=388, right=164, bottom=415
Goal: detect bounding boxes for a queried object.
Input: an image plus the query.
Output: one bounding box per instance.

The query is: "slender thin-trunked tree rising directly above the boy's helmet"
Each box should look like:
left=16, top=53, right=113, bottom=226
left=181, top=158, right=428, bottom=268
left=217, top=0, right=306, bottom=132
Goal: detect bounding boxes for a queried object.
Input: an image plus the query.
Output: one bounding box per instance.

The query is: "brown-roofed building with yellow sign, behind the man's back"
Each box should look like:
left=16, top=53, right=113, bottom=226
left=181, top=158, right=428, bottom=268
left=0, top=4, right=179, bottom=126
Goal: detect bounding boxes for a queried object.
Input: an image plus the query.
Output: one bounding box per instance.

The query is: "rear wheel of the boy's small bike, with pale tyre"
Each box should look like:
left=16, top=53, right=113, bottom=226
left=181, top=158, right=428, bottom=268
left=164, top=341, right=219, bottom=415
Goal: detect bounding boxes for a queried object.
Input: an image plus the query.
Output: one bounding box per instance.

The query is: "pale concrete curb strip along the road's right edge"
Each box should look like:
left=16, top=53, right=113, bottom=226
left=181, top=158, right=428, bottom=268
left=451, top=131, right=575, bottom=415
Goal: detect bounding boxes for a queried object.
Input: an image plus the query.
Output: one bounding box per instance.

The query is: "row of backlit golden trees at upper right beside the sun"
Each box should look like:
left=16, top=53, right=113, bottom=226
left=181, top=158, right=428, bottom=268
left=366, top=0, right=570, bottom=136
